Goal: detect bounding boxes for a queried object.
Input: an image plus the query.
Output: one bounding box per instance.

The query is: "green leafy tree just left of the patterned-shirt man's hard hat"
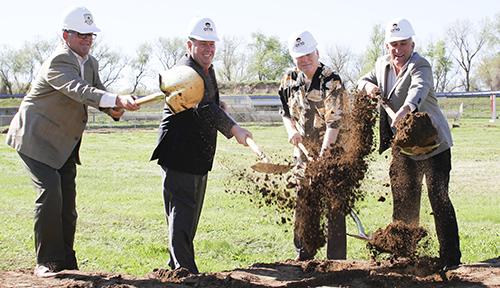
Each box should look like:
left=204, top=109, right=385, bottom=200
left=248, top=32, right=293, bottom=81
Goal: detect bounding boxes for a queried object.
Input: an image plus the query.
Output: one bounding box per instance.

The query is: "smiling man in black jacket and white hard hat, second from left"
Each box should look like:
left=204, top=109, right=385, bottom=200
left=151, top=18, right=252, bottom=274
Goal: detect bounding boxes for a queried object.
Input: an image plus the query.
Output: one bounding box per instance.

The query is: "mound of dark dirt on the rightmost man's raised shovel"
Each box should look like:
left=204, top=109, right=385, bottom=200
left=392, top=112, right=438, bottom=148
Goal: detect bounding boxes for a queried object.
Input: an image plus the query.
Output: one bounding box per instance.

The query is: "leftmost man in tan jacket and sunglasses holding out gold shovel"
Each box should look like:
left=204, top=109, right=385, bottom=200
left=6, top=7, right=139, bottom=277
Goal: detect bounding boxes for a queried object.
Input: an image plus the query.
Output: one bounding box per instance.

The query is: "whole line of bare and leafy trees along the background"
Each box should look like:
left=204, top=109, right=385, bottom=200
left=0, top=13, right=500, bottom=94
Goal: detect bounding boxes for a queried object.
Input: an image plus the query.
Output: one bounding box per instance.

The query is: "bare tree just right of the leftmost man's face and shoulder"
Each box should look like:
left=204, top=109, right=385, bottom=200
left=92, top=42, right=128, bottom=88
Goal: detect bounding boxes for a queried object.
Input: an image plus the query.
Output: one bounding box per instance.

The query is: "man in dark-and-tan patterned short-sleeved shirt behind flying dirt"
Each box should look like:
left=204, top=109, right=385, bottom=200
left=278, top=31, right=347, bottom=261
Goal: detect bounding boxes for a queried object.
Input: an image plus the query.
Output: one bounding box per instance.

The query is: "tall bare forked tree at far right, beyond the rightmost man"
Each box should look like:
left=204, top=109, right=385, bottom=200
left=447, top=20, right=487, bottom=91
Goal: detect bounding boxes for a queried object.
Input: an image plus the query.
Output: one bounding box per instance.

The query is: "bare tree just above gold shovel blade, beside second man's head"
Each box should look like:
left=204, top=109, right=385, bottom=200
left=154, top=37, right=186, bottom=69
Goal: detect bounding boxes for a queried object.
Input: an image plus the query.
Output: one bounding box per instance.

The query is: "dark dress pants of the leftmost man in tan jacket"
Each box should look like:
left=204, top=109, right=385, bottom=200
left=19, top=153, right=77, bottom=269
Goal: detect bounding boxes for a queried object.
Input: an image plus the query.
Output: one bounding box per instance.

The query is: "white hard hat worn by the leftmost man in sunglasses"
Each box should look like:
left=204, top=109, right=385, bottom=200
left=63, top=7, right=101, bottom=34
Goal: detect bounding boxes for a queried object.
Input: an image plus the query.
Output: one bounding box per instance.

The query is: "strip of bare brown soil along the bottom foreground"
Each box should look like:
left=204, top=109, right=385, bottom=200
left=0, top=258, right=500, bottom=288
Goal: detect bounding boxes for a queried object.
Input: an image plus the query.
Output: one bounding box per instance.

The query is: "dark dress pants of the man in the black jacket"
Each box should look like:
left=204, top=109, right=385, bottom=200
left=162, top=166, right=207, bottom=274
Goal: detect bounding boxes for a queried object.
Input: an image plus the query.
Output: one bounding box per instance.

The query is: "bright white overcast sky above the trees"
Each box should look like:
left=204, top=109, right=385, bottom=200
left=0, top=0, right=500, bottom=54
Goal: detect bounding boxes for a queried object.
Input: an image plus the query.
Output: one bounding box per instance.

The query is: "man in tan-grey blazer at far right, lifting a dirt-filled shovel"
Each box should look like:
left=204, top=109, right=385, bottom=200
left=358, top=19, right=461, bottom=269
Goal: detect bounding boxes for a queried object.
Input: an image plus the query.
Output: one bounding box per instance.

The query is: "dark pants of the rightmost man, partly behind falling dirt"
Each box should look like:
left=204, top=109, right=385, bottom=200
left=389, top=148, right=461, bottom=266
